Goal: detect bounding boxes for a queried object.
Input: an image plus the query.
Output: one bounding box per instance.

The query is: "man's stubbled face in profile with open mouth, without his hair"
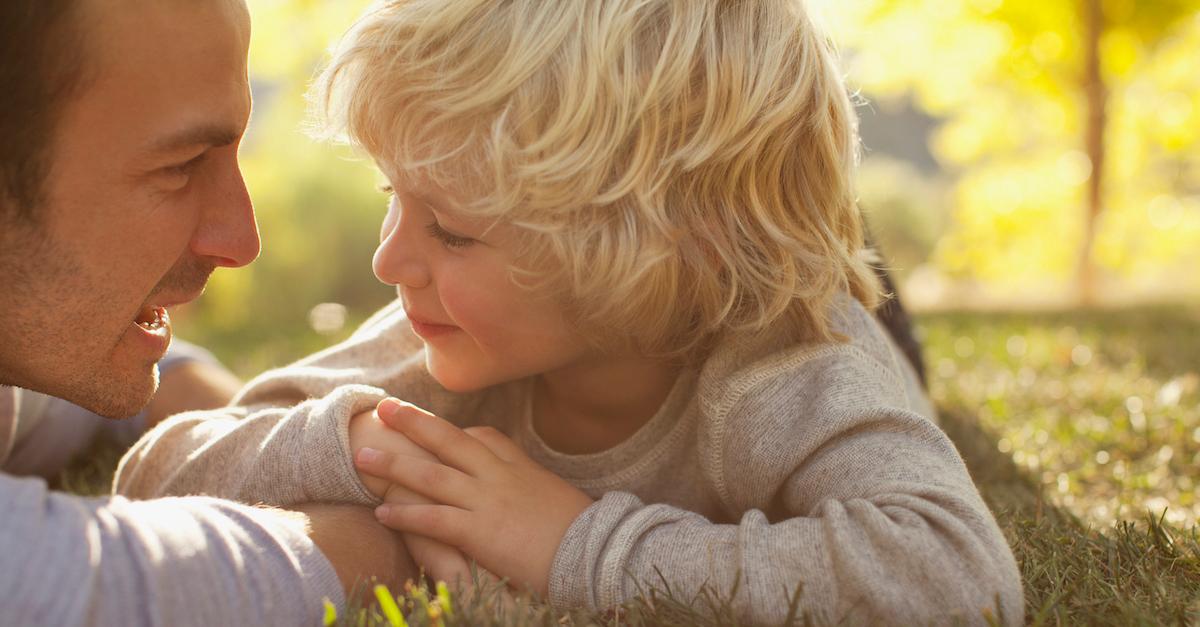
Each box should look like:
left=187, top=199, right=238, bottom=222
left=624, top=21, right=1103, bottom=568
left=0, top=0, right=259, bottom=417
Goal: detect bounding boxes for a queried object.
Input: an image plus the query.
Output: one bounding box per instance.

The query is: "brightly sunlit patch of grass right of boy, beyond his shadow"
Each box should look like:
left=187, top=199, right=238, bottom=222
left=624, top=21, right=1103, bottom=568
left=920, top=306, right=1200, bottom=526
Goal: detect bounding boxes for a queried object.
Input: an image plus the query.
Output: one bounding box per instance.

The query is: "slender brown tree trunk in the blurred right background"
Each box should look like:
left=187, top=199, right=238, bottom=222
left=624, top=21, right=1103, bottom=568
left=1079, top=0, right=1108, bottom=305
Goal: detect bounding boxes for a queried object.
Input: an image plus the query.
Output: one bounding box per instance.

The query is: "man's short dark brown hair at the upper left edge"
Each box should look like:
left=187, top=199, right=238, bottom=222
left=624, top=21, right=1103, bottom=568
left=0, top=0, right=83, bottom=220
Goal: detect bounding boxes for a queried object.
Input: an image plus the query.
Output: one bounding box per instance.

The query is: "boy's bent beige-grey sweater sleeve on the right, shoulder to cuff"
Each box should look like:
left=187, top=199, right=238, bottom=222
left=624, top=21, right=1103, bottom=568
left=550, top=360, right=1024, bottom=625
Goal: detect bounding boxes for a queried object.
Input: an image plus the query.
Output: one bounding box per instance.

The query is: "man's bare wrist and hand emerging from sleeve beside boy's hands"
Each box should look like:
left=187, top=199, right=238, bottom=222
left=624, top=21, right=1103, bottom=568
left=284, top=503, right=418, bottom=601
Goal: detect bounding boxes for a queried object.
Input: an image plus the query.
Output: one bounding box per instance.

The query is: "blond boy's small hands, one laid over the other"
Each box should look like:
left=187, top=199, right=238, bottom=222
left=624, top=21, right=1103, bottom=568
left=350, top=399, right=593, bottom=597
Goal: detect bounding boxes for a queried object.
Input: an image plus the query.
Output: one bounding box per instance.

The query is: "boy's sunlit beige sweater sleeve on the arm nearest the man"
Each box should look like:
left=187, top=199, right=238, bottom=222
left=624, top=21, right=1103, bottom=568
left=113, top=297, right=424, bottom=506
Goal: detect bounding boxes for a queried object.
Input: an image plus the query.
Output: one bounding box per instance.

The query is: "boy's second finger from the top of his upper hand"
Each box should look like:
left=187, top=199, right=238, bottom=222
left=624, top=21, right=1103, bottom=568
left=354, top=448, right=474, bottom=507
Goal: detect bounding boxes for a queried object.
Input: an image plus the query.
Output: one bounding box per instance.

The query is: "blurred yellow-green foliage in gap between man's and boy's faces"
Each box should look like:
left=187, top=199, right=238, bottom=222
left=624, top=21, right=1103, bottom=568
left=176, top=0, right=395, bottom=376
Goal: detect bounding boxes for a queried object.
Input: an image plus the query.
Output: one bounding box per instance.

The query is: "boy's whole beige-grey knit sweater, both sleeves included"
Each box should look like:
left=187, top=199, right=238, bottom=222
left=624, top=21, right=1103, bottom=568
left=115, top=298, right=1024, bottom=625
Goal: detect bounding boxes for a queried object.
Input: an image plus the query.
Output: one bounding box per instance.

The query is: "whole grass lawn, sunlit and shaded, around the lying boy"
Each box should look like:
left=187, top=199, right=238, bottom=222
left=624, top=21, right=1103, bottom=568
left=62, top=301, right=1200, bottom=626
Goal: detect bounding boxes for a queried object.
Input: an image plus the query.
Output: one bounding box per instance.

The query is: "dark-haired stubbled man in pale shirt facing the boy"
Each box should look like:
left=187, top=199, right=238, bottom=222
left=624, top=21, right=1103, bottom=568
left=0, top=0, right=412, bottom=625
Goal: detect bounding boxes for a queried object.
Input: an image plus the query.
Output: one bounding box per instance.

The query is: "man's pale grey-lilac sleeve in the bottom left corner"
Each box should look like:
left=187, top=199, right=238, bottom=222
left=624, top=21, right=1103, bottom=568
left=0, top=476, right=344, bottom=626
